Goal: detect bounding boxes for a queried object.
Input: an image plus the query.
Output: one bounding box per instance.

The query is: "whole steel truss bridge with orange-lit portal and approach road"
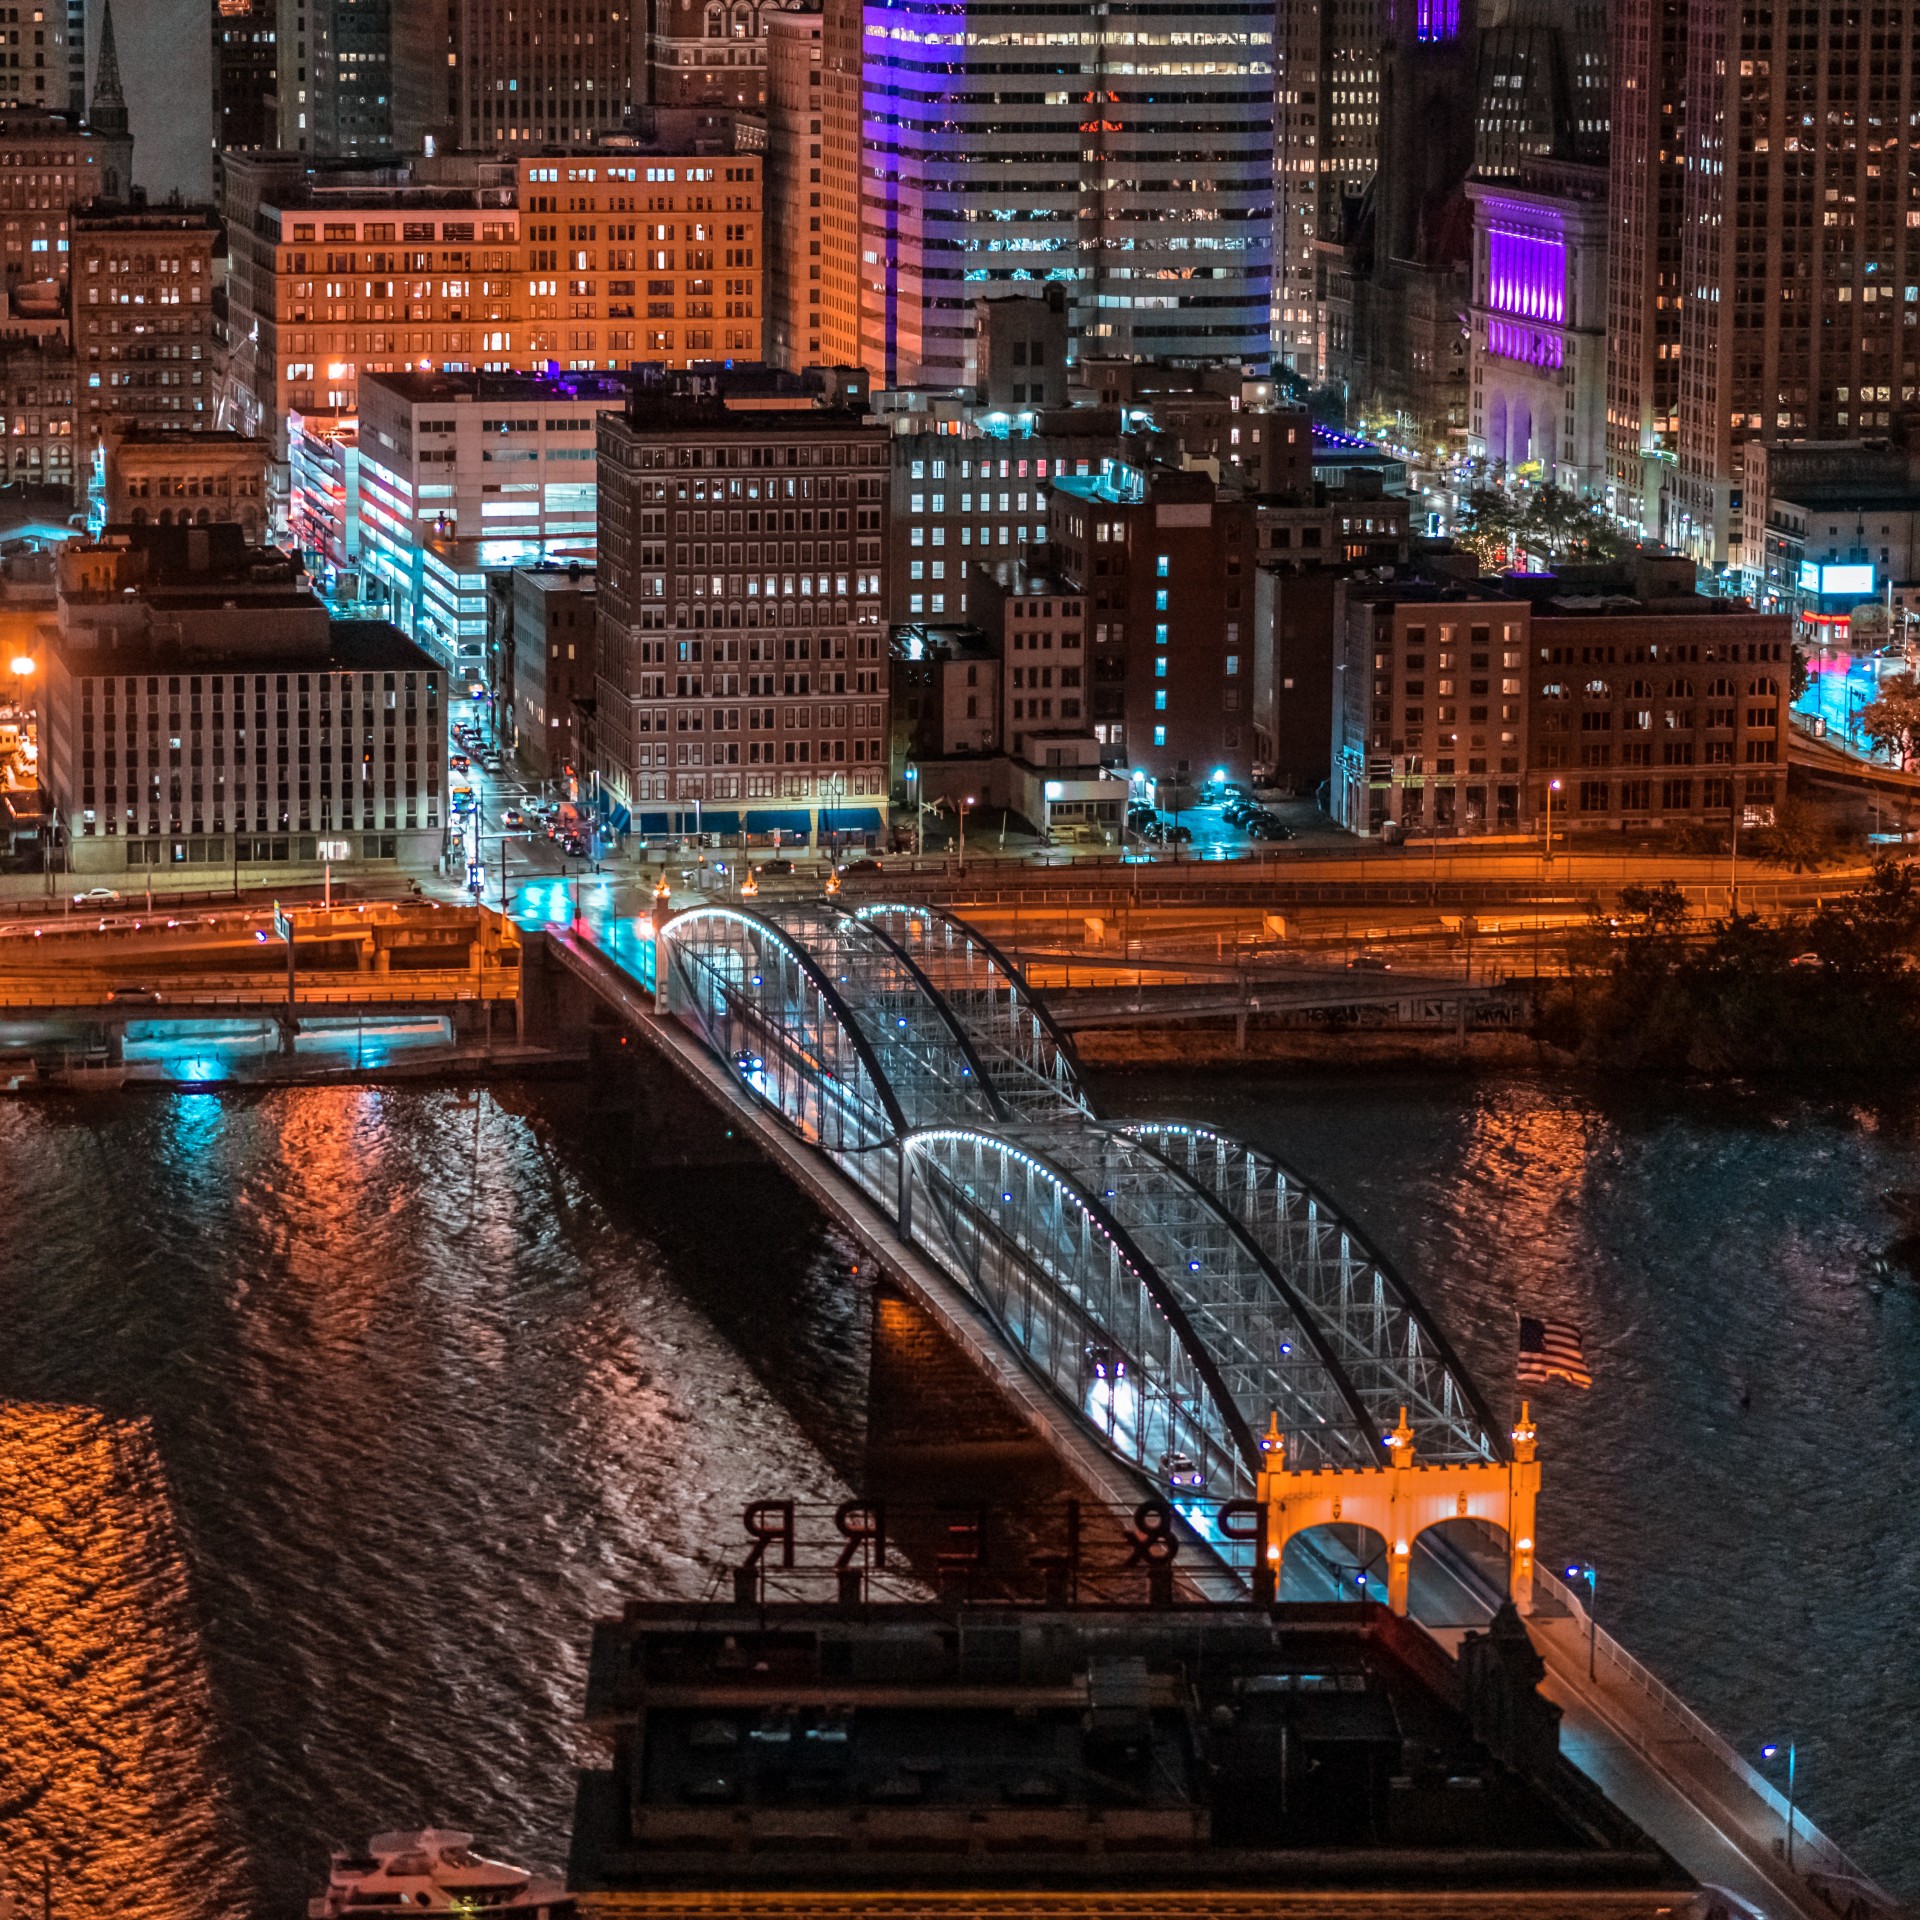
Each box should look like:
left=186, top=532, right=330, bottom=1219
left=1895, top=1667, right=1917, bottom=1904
left=528, top=900, right=1893, bottom=1920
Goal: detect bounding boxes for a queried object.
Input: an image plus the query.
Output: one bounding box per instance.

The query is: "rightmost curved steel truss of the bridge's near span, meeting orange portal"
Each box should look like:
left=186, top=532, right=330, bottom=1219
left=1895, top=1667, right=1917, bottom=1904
left=1127, top=1121, right=1505, bottom=1461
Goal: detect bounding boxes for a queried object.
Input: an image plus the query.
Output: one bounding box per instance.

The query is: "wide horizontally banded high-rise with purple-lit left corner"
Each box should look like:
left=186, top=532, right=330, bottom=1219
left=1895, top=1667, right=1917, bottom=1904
left=824, top=0, right=1273, bottom=388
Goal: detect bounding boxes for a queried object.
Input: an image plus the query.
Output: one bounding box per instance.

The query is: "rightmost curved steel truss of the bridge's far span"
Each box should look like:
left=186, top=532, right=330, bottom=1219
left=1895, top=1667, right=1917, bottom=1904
left=856, top=900, right=1092, bottom=1121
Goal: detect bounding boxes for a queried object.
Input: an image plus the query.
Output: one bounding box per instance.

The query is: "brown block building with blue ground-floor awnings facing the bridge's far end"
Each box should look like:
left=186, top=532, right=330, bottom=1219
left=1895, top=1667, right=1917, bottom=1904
left=595, top=360, right=889, bottom=837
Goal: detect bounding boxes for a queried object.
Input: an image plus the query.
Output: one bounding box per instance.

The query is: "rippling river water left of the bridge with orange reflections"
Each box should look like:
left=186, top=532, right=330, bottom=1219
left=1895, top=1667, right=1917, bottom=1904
left=0, top=1089, right=864, bottom=1920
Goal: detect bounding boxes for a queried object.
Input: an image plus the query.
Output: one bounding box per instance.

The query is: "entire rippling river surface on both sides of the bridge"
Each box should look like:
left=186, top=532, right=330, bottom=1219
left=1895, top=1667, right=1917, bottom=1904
left=0, top=1075, right=1920, bottom=1920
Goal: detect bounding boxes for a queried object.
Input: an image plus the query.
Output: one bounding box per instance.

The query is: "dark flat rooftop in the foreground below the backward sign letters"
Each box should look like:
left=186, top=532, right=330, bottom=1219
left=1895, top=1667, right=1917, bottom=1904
left=570, top=1601, right=1692, bottom=1916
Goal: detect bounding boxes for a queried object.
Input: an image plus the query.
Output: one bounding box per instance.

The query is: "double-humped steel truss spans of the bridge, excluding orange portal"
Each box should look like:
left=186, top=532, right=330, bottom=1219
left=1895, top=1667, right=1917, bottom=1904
left=664, top=902, right=1503, bottom=1498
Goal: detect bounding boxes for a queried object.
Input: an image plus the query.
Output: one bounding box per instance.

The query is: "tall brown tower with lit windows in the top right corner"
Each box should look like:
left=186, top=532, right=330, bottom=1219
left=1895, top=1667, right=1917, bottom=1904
left=1663, top=0, right=1920, bottom=568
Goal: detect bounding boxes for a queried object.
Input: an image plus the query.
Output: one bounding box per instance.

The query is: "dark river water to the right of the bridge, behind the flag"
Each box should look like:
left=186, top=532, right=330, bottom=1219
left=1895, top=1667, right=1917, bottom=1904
left=1100, top=1073, right=1920, bottom=1897
